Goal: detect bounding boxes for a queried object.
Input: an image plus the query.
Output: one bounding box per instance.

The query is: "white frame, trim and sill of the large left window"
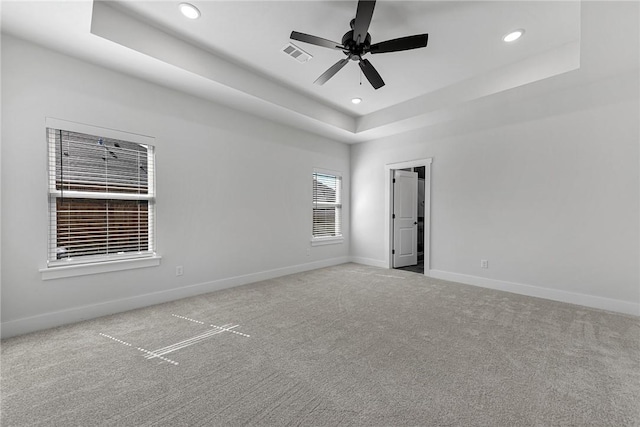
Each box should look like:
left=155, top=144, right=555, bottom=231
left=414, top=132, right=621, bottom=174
left=40, top=118, right=161, bottom=280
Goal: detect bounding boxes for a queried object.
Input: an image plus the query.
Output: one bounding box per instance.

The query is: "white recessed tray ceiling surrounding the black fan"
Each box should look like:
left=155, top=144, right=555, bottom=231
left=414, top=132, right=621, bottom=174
left=1, top=0, right=580, bottom=142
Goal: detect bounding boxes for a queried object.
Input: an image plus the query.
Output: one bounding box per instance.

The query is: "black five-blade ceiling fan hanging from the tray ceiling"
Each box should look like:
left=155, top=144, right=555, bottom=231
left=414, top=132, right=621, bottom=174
left=290, top=0, right=429, bottom=89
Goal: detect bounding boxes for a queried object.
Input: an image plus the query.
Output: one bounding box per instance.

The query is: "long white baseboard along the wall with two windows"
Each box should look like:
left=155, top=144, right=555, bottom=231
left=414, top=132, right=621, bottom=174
left=0, top=256, right=350, bottom=338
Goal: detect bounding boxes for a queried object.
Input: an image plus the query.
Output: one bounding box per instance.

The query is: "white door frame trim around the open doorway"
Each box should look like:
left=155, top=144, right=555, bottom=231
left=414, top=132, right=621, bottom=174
left=384, top=158, right=433, bottom=276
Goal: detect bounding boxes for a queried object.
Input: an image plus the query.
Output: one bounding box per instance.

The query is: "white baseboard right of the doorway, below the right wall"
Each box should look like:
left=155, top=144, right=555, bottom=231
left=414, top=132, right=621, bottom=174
left=429, top=270, right=640, bottom=316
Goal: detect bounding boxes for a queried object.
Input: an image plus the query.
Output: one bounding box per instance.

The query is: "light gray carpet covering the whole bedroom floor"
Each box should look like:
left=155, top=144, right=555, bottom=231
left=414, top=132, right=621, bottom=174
left=0, top=264, right=640, bottom=426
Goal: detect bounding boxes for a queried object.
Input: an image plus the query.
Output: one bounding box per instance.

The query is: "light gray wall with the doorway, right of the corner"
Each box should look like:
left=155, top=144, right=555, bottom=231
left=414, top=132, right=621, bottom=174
left=351, top=2, right=640, bottom=314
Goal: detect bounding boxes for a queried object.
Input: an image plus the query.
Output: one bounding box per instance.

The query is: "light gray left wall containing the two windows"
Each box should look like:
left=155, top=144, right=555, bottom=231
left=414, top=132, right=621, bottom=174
left=1, top=35, right=350, bottom=336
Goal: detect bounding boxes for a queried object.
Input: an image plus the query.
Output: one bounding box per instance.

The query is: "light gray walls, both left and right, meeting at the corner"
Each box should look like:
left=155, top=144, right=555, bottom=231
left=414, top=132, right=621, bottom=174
left=0, top=2, right=640, bottom=336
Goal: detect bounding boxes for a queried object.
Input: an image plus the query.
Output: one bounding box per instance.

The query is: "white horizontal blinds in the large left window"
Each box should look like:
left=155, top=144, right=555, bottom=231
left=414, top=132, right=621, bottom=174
left=47, top=128, right=155, bottom=267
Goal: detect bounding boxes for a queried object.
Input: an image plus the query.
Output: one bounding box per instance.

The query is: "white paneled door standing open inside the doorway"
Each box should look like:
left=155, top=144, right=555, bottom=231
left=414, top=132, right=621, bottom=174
left=393, top=170, right=418, bottom=268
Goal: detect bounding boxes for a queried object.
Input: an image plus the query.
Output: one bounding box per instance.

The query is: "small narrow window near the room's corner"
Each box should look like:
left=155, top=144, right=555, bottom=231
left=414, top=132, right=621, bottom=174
left=312, top=171, right=342, bottom=244
